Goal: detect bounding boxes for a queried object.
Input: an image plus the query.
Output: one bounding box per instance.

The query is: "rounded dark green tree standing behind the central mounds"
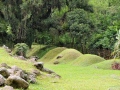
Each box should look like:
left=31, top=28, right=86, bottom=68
left=67, top=9, right=92, bottom=52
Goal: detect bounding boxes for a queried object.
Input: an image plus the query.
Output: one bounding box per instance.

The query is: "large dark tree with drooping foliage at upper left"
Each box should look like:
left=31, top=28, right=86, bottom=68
left=1, top=0, right=65, bottom=47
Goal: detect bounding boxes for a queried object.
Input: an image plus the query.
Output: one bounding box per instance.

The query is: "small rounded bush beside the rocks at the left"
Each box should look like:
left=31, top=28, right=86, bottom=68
left=13, top=43, right=29, bottom=57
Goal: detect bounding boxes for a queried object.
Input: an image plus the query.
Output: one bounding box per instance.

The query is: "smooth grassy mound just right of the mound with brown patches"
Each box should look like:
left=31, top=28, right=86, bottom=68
left=72, top=54, right=105, bottom=66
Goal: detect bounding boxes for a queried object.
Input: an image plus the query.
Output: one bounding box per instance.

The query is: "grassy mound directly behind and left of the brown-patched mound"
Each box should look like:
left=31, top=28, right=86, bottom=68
left=40, top=47, right=66, bottom=62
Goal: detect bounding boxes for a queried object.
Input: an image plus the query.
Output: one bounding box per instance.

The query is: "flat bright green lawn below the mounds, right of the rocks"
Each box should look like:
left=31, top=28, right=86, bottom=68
left=30, top=64, right=120, bottom=90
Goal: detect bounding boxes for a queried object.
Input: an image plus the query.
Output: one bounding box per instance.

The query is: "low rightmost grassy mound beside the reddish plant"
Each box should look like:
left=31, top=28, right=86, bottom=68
left=91, top=59, right=120, bottom=70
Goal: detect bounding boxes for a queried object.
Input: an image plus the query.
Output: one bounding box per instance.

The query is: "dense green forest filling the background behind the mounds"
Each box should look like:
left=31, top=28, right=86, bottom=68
left=0, top=0, right=120, bottom=58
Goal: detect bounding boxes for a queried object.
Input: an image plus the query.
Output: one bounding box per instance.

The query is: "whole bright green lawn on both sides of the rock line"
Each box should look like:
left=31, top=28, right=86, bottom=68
left=0, top=48, right=120, bottom=90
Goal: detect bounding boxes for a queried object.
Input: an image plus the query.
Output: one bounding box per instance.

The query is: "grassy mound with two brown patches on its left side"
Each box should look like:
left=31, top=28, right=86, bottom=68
left=51, top=49, right=82, bottom=63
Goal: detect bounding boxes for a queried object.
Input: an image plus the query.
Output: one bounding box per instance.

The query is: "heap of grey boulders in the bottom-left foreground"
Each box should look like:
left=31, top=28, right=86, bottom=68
left=0, top=63, right=40, bottom=90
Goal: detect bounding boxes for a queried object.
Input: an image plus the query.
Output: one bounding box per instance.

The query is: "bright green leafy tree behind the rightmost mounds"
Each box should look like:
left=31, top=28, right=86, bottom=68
left=91, top=26, right=117, bottom=50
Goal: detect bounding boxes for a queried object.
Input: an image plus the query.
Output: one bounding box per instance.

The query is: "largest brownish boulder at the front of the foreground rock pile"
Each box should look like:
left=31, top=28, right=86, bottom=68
left=5, top=75, right=29, bottom=89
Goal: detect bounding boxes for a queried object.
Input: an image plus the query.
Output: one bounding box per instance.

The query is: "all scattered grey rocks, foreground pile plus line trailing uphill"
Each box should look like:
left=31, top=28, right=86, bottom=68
left=0, top=45, right=62, bottom=90
